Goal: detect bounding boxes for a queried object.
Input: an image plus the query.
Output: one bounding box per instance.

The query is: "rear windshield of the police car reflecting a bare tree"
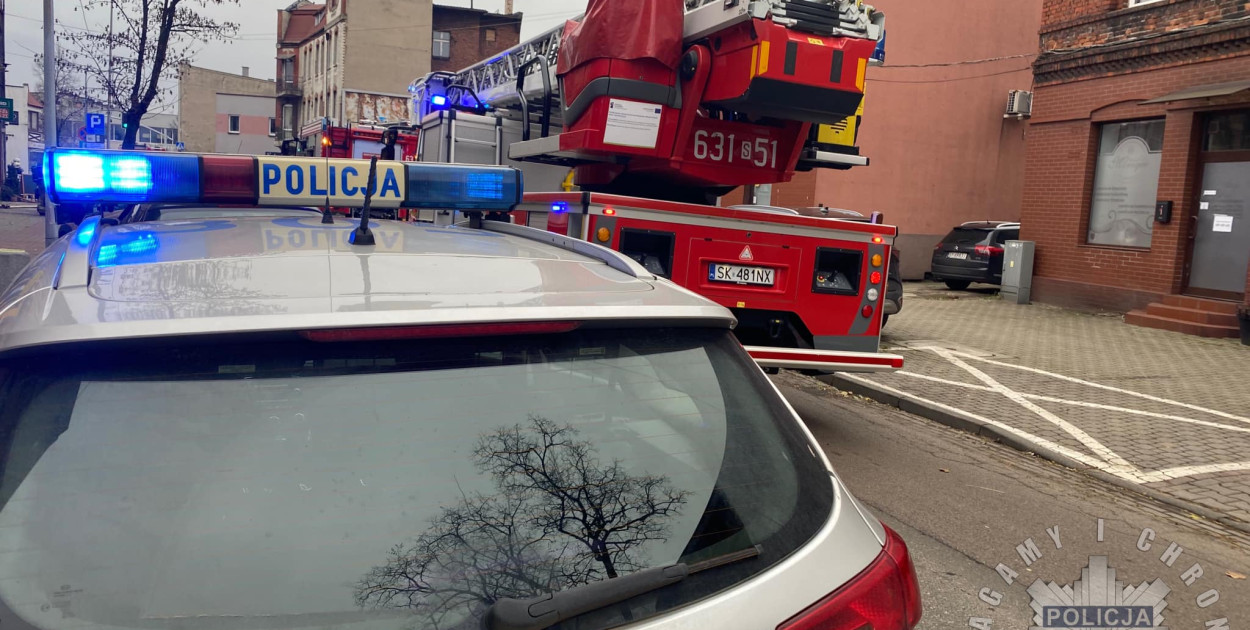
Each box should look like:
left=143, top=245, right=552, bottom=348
left=0, top=329, right=833, bottom=630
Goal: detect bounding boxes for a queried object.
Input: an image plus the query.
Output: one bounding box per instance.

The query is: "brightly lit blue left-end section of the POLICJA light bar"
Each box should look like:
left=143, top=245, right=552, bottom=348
left=45, top=149, right=200, bottom=204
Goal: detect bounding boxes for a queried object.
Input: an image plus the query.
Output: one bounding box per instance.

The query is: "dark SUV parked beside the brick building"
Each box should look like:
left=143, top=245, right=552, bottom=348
left=933, top=221, right=1020, bottom=290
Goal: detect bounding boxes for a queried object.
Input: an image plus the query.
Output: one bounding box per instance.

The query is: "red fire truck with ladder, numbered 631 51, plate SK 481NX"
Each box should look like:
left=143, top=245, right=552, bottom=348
left=410, top=0, right=901, bottom=371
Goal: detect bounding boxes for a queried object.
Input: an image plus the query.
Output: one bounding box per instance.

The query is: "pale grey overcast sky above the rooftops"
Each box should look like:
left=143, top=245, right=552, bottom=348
left=5, top=0, right=586, bottom=95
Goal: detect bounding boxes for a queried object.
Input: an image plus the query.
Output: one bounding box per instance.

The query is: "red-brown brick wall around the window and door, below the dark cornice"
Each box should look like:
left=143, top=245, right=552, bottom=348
left=1021, top=53, right=1250, bottom=310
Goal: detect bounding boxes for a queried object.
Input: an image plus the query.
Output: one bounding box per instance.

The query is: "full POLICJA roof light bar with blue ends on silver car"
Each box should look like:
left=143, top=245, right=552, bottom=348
left=44, top=149, right=524, bottom=210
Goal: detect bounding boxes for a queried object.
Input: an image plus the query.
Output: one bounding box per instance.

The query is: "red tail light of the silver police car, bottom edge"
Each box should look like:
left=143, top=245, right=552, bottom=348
left=778, top=528, right=921, bottom=630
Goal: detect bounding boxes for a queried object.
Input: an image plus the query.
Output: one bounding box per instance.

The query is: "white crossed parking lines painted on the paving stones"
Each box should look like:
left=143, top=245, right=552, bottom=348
left=843, top=345, right=1250, bottom=484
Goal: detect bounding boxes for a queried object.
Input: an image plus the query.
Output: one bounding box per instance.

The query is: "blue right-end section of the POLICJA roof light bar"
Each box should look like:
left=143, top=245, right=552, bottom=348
left=404, top=164, right=524, bottom=210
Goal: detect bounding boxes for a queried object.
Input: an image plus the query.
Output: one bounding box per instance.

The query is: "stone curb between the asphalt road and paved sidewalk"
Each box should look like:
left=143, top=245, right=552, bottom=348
left=821, top=374, right=1250, bottom=534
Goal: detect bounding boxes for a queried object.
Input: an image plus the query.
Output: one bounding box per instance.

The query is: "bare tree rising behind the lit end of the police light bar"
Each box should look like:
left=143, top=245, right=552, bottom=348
left=65, top=0, right=239, bottom=149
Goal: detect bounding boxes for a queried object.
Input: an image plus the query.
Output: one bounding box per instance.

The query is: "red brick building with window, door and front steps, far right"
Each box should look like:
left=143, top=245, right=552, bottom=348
left=1021, top=0, right=1250, bottom=336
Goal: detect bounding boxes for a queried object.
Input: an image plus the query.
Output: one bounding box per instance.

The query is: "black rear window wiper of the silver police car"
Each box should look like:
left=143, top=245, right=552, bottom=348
left=483, top=545, right=760, bottom=630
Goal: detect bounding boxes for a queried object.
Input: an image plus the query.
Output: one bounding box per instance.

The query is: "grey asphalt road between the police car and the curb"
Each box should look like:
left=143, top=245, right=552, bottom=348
left=776, top=373, right=1250, bottom=630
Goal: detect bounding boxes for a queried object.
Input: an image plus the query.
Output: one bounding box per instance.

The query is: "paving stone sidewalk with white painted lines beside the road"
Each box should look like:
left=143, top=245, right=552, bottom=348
left=835, top=283, right=1250, bottom=529
